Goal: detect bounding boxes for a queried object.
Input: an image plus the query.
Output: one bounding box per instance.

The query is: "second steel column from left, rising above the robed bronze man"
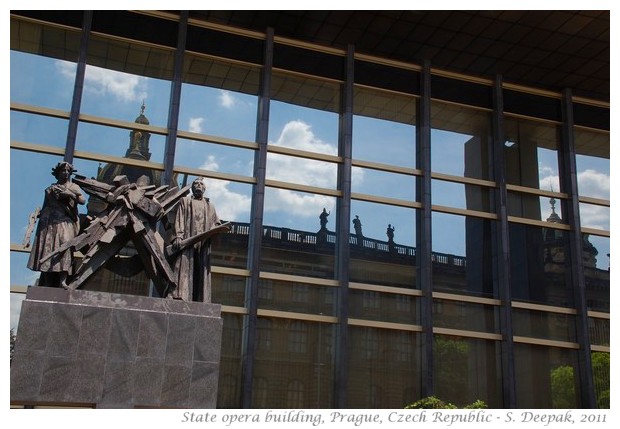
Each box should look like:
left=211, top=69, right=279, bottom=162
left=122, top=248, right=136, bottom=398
left=161, top=10, right=189, bottom=185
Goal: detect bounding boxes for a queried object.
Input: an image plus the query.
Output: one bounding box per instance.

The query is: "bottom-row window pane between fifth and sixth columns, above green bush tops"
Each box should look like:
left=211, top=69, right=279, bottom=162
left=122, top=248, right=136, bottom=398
left=433, top=335, right=502, bottom=408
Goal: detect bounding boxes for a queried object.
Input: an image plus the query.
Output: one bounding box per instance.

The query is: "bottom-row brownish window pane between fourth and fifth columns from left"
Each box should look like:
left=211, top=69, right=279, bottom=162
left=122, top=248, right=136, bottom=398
left=347, top=326, right=421, bottom=408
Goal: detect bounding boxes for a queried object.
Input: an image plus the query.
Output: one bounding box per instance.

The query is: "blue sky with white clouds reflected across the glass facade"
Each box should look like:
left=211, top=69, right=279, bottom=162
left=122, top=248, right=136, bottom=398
left=10, top=51, right=610, bottom=326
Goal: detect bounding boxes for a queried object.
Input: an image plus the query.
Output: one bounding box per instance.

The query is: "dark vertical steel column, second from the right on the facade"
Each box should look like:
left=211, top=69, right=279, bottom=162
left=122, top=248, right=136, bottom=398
left=491, top=75, right=517, bottom=408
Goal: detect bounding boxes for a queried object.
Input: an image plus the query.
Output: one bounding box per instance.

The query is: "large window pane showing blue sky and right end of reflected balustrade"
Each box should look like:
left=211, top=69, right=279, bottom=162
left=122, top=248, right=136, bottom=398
left=432, top=212, right=495, bottom=296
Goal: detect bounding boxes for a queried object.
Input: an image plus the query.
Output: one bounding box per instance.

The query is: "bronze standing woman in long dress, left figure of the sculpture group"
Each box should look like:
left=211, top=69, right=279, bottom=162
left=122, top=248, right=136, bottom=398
left=28, top=162, right=86, bottom=288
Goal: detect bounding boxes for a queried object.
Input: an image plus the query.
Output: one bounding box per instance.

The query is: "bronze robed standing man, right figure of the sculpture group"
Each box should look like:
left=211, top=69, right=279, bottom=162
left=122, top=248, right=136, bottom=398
left=168, top=178, right=226, bottom=302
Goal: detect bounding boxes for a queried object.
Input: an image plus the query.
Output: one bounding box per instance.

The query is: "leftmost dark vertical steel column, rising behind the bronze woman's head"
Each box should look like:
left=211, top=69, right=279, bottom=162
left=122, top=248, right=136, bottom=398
left=64, top=10, right=93, bottom=163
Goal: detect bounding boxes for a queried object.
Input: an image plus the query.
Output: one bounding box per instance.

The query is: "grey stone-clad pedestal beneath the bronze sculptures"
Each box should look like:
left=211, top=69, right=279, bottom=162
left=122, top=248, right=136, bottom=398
left=11, top=287, right=222, bottom=408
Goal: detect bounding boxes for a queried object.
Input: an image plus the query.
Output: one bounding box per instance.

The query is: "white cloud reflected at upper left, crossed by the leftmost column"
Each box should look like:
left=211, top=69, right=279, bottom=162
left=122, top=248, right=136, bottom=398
left=56, top=61, right=147, bottom=102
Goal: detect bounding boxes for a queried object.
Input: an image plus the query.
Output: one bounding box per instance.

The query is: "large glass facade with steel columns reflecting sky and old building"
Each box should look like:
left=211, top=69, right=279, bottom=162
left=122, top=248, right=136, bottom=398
left=10, top=11, right=610, bottom=408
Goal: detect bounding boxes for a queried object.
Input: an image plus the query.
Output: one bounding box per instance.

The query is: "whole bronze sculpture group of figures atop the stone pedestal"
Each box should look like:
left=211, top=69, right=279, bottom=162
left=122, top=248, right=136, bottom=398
left=28, top=162, right=230, bottom=302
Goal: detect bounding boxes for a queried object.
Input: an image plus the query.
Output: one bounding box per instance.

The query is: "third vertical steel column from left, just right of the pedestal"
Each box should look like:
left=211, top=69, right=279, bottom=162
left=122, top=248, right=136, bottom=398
left=240, top=28, right=273, bottom=408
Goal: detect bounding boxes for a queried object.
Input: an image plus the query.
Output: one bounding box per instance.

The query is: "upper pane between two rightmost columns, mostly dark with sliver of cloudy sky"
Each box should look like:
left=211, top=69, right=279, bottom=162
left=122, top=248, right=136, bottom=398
left=504, top=118, right=562, bottom=192
